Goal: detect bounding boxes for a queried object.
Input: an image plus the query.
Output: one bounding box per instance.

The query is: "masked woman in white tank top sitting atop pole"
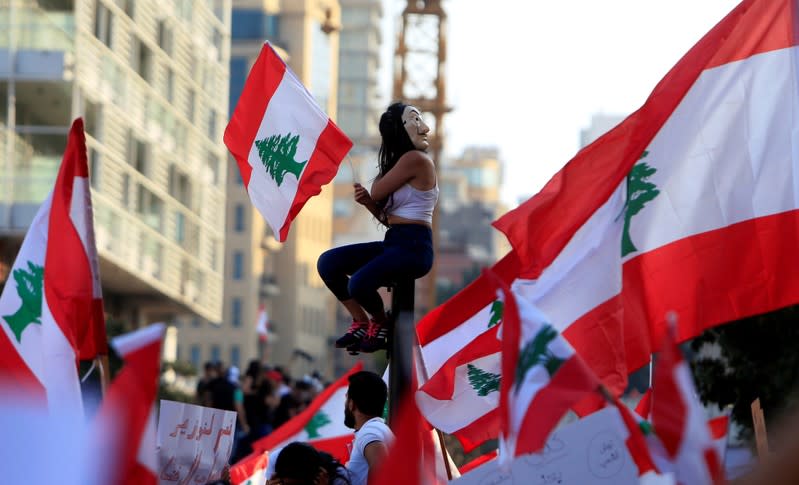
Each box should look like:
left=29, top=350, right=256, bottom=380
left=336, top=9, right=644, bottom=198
left=317, top=103, right=438, bottom=352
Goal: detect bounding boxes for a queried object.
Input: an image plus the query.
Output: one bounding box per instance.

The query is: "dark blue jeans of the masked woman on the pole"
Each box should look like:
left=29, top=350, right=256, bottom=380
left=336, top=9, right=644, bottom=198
left=316, top=224, right=433, bottom=315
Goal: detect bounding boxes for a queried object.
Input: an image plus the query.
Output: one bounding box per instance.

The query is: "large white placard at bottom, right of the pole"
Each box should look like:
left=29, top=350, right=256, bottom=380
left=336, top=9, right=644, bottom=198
left=450, top=408, right=638, bottom=485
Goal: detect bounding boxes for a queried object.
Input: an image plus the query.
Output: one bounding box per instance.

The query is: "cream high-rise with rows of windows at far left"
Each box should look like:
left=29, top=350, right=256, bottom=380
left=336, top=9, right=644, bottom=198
left=0, top=0, right=230, bottom=326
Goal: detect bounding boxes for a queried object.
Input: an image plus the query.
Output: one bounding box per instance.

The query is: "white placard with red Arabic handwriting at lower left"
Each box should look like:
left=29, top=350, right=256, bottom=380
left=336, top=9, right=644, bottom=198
left=158, top=400, right=236, bottom=485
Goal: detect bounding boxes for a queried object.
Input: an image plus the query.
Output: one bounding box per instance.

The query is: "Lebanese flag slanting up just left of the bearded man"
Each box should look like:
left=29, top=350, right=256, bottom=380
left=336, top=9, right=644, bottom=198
left=252, top=362, right=363, bottom=458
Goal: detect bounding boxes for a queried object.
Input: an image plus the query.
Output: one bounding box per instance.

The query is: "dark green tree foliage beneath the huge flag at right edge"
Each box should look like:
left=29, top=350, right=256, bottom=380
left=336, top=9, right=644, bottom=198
left=691, top=306, right=799, bottom=440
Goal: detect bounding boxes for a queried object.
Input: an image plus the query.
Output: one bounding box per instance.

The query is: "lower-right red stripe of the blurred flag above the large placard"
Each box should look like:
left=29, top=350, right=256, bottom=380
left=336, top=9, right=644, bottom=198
left=503, top=354, right=599, bottom=456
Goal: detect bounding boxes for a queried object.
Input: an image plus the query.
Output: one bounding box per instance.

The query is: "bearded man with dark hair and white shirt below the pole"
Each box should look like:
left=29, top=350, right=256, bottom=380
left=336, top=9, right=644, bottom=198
left=344, top=371, right=394, bottom=485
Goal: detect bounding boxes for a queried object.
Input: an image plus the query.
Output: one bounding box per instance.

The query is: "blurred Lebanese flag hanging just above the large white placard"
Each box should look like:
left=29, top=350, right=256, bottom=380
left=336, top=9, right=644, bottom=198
left=496, top=268, right=600, bottom=467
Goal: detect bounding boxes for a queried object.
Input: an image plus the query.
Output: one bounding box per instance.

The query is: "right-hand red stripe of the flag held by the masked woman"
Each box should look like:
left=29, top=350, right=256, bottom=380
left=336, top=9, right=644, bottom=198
left=280, top=120, right=352, bottom=241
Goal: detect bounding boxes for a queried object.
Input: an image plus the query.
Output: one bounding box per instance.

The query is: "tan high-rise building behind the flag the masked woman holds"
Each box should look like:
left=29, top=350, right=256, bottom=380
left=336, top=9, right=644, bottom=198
left=179, top=0, right=340, bottom=375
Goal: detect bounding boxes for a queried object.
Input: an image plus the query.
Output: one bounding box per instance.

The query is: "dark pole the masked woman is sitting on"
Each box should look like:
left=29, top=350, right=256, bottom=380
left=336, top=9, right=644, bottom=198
left=388, top=279, right=416, bottom=426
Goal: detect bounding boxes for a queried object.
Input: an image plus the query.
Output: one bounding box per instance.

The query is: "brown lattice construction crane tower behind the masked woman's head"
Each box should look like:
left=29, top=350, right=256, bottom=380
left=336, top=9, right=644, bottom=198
left=392, top=0, right=451, bottom=313
